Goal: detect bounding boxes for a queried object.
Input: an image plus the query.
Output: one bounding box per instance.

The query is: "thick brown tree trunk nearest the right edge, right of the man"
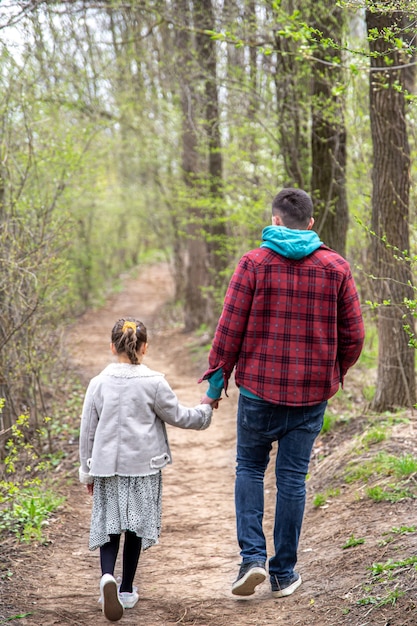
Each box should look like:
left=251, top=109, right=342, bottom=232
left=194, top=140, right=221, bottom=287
left=366, top=10, right=416, bottom=412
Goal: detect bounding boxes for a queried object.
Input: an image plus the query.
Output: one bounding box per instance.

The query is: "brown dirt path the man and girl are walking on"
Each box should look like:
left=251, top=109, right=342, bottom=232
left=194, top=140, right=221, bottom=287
left=0, top=265, right=417, bottom=626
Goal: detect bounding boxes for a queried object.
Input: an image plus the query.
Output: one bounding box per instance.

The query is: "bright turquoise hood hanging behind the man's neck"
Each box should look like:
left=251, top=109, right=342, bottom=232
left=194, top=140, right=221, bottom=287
left=261, top=226, right=322, bottom=260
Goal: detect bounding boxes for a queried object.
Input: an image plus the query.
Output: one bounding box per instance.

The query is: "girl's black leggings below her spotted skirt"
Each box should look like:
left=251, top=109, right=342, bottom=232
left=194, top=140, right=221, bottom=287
left=100, top=530, right=142, bottom=593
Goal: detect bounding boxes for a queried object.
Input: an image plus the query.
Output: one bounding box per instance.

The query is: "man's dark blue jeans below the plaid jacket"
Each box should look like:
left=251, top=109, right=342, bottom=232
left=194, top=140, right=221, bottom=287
left=235, top=394, right=327, bottom=583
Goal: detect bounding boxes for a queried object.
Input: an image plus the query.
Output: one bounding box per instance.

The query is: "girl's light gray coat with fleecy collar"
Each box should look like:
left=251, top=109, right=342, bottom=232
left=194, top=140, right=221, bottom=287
left=79, top=363, right=212, bottom=484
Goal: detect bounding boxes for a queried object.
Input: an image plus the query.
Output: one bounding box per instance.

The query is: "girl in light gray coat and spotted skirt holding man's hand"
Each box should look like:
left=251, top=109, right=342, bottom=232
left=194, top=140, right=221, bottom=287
left=79, top=318, right=212, bottom=621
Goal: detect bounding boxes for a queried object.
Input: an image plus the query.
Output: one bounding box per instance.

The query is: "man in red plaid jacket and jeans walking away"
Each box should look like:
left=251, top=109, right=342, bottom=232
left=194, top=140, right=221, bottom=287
left=201, top=189, right=364, bottom=598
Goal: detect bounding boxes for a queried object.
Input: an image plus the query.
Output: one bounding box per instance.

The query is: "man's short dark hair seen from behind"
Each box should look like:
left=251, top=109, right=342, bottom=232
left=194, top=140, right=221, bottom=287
left=272, top=187, right=313, bottom=229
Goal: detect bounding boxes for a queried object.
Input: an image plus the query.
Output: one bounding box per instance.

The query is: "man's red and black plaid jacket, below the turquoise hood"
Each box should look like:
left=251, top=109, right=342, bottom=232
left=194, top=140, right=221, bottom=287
left=202, top=246, right=364, bottom=406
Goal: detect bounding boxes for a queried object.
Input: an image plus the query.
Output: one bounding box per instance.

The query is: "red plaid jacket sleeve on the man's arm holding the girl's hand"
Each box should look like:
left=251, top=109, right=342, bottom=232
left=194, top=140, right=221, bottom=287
left=200, top=255, right=256, bottom=391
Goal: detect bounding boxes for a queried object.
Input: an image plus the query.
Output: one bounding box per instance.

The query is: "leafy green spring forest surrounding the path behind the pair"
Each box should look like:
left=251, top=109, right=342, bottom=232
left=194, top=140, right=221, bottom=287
left=0, top=0, right=417, bottom=544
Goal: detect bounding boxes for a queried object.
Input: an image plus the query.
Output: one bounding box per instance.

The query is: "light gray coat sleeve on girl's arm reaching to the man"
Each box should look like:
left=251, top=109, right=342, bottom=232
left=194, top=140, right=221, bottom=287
left=154, top=378, right=213, bottom=430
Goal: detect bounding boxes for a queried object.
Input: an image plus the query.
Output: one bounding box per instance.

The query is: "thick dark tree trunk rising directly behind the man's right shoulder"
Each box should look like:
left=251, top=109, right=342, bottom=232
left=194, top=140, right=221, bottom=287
left=311, top=0, right=348, bottom=256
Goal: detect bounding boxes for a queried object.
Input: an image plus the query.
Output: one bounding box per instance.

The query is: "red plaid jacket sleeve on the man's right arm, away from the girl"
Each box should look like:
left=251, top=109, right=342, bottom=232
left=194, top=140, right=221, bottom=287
left=337, top=270, right=365, bottom=382
